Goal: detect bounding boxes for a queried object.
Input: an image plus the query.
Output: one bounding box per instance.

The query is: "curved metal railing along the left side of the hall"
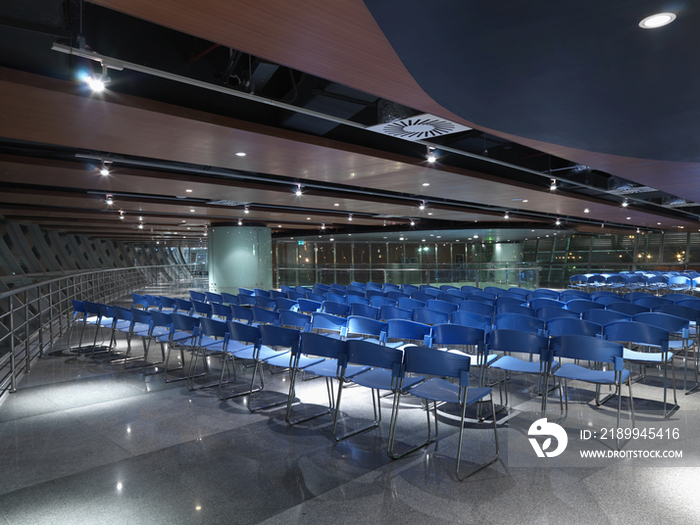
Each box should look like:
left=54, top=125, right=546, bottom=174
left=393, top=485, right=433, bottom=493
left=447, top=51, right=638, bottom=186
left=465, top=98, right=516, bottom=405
left=0, top=264, right=197, bottom=401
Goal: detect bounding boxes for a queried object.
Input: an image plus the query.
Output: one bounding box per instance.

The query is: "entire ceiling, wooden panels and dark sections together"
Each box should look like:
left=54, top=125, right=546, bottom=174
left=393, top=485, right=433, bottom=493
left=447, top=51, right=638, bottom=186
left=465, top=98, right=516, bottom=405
left=0, top=0, right=700, bottom=246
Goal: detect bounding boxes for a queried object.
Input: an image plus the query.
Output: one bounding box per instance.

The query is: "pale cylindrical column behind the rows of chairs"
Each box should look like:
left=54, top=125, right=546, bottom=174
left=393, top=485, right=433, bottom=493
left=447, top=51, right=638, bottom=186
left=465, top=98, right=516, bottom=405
left=207, top=224, right=272, bottom=294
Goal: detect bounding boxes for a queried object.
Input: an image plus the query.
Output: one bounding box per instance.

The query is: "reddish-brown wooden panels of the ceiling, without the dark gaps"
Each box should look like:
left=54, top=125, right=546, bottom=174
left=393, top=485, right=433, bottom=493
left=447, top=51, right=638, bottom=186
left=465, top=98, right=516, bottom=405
left=0, top=0, right=697, bottom=244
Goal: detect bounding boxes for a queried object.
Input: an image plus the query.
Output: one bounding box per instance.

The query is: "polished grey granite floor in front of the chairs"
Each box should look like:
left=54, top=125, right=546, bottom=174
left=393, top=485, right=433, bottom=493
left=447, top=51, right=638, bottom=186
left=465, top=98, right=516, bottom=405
left=0, top=314, right=700, bottom=525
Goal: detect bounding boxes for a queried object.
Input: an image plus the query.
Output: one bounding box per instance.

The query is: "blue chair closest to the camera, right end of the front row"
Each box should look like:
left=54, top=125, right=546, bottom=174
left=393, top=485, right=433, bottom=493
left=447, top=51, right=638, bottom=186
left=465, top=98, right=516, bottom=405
left=387, top=346, right=499, bottom=481
